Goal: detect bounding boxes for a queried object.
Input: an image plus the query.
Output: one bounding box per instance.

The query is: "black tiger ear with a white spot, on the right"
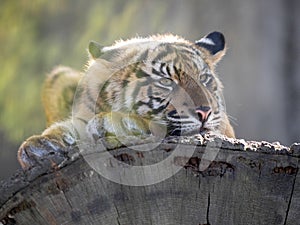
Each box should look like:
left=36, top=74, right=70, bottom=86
left=195, top=31, right=226, bottom=64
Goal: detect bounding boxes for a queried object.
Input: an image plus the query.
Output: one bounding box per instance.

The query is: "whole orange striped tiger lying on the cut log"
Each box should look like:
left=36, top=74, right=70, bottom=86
left=18, top=32, right=235, bottom=169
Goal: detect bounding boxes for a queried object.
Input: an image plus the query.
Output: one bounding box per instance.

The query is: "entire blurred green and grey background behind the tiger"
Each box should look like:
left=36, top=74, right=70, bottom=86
left=0, top=0, right=300, bottom=178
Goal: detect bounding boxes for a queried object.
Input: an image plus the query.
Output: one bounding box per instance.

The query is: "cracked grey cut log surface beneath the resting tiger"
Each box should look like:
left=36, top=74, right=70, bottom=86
left=0, top=136, right=300, bottom=225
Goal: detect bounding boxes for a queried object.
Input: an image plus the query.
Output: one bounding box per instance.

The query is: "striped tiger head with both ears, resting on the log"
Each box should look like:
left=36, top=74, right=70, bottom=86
left=79, top=32, right=234, bottom=137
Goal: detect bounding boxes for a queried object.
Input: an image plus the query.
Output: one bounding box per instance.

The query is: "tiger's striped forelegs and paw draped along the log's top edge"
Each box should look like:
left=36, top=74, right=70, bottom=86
left=18, top=112, right=166, bottom=169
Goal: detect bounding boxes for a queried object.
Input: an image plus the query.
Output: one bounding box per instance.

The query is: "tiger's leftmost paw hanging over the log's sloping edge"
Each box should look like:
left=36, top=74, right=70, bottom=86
left=18, top=136, right=75, bottom=170
